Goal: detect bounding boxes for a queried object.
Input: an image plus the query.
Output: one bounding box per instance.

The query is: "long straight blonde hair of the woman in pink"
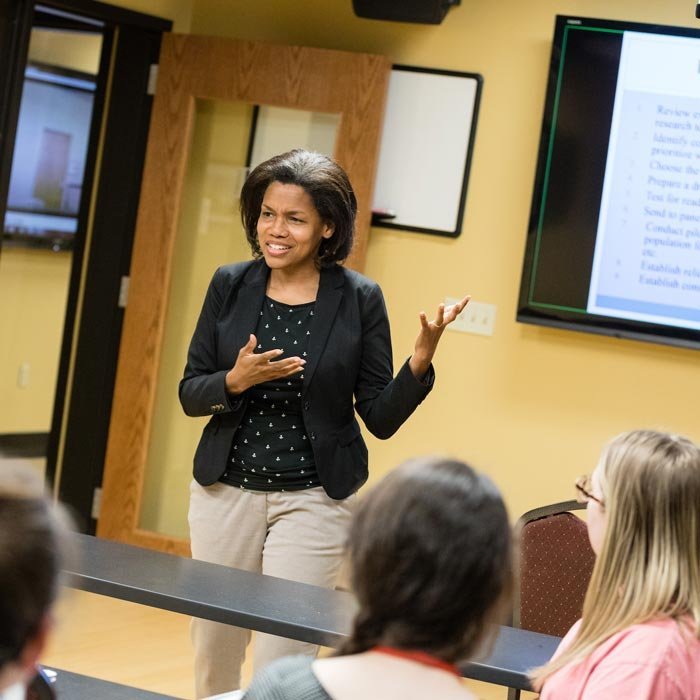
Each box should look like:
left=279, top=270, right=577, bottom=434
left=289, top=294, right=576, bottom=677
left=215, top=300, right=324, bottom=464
left=532, top=430, right=700, bottom=690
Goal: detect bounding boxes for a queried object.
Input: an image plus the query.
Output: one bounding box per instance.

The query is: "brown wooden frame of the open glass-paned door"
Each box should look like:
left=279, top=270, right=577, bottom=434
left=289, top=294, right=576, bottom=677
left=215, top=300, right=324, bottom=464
left=97, top=34, right=391, bottom=554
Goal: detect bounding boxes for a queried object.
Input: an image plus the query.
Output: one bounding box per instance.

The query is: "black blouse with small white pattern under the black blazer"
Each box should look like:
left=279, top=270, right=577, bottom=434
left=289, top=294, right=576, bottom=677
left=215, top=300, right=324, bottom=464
left=220, top=296, right=321, bottom=491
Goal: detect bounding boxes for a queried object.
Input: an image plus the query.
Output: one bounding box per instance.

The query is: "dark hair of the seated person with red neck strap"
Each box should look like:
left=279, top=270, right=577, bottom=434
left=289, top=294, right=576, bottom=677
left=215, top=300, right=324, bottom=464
left=339, top=457, right=513, bottom=663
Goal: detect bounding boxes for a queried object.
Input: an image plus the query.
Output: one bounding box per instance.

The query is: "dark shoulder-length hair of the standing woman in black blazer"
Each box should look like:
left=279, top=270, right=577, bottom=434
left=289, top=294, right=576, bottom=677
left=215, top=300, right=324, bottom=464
left=240, top=148, right=357, bottom=267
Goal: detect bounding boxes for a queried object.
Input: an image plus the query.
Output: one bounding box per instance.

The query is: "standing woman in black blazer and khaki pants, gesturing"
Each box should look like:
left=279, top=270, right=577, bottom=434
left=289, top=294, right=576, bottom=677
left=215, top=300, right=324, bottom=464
left=180, top=150, right=468, bottom=697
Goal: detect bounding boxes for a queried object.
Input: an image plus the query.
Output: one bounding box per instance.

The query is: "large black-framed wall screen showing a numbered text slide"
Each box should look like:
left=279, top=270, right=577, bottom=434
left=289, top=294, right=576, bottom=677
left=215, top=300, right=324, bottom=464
left=517, top=16, right=700, bottom=348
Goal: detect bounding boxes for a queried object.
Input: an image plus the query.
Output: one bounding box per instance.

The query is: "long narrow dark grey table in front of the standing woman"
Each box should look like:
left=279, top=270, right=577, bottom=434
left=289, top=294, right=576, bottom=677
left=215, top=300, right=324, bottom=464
left=66, top=535, right=559, bottom=690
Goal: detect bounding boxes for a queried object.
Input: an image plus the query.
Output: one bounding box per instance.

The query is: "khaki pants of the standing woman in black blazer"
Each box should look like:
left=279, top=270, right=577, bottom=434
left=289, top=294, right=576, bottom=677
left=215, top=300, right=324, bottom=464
left=189, top=481, right=355, bottom=698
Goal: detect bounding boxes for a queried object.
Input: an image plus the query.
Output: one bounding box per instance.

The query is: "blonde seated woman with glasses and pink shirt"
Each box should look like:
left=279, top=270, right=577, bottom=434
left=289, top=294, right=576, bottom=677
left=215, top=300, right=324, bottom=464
left=533, top=430, right=700, bottom=700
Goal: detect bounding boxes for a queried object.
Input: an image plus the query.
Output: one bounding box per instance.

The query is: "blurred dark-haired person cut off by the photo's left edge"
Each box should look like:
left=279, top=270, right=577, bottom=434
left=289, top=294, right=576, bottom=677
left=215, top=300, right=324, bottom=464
left=0, top=466, right=72, bottom=700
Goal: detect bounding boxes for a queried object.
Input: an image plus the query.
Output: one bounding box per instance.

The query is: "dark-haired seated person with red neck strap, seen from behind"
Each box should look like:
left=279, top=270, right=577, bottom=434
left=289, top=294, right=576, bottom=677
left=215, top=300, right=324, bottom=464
left=244, top=458, right=512, bottom=700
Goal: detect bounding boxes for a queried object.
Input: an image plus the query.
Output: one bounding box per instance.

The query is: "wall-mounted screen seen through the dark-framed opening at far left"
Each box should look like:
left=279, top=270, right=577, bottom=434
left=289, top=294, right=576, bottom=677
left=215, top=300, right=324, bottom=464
left=3, top=63, right=96, bottom=250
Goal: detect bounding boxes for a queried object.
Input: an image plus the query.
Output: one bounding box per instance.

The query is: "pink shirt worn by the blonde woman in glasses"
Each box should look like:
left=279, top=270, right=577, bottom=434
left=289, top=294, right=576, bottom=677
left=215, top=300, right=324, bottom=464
left=540, top=619, right=700, bottom=700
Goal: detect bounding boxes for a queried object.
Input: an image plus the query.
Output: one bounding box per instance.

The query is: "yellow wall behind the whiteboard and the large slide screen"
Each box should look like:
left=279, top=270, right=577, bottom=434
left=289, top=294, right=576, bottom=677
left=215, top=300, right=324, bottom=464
left=172, top=0, right=700, bottom=516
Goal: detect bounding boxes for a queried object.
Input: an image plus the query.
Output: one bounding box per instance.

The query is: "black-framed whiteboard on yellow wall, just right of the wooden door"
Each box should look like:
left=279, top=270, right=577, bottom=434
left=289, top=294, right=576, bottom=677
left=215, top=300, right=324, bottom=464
left=372, top=66, right=483, bottom=236
